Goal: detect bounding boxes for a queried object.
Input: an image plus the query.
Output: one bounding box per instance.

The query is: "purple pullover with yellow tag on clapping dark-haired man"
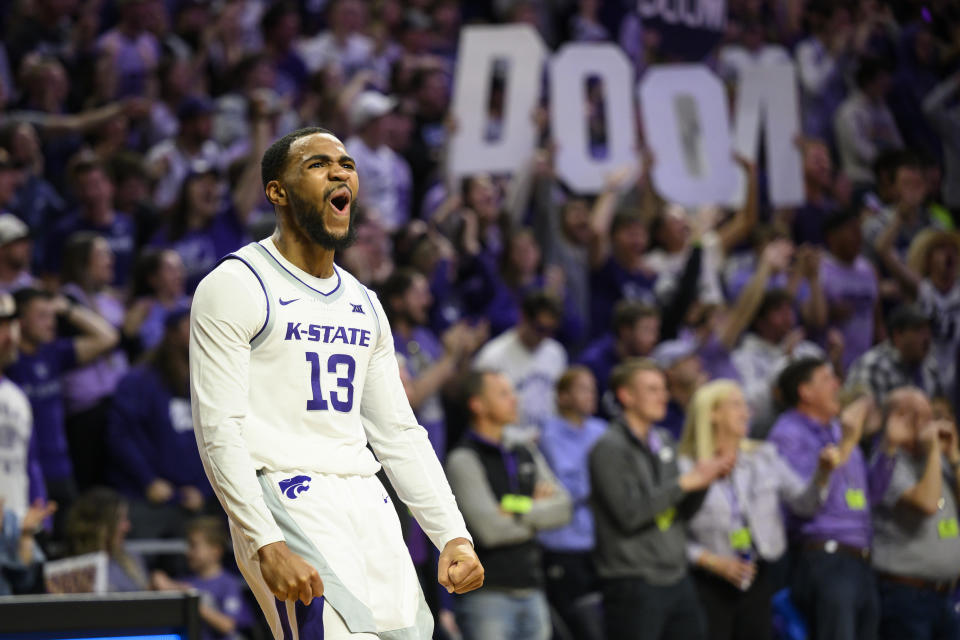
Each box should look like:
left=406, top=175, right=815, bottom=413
left=768, top=410, right=873, bottom=548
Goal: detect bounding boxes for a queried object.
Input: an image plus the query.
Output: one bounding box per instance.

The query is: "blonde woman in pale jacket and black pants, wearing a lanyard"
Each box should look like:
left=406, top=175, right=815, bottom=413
left=678, top=379, right=840, bottom=640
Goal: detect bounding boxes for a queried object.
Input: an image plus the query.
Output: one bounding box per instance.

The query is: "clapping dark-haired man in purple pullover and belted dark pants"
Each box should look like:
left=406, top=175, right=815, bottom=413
left=769, top=358, right=880, bottom=640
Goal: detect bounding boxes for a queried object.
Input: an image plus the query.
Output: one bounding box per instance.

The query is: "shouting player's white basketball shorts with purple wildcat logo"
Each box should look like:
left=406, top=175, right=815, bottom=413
left=231, top=471, right=433, bottom=640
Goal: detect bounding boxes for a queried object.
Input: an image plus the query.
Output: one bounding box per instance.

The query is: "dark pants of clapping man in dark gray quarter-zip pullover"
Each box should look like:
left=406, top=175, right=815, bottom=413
left=603, top=576, right=707, bottom=640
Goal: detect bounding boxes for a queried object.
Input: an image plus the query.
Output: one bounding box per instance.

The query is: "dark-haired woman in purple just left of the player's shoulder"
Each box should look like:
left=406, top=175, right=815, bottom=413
left=123, top=247, right=190, bottom=351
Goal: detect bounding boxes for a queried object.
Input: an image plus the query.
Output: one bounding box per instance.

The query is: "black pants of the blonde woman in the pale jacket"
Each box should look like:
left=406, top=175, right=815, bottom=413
left=693, top=562, right=774, bottom=640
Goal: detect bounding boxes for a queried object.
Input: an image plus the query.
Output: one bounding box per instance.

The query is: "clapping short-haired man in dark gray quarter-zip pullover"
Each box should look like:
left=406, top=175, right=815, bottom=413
left=590, top=359, right=734, bottom=640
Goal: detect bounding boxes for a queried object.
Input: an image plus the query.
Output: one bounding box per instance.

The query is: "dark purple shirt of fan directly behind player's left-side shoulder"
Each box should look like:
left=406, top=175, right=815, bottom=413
left=150, top=207, right=250, bottom=293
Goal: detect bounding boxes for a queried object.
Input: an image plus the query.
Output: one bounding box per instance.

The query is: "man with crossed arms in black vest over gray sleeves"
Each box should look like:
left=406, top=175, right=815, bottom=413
left=447, top=371, right=572, bottom=640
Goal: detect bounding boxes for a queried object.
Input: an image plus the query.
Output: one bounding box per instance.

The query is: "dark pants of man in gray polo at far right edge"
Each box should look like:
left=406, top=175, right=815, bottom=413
left=877, top=579, right=960, bottom=640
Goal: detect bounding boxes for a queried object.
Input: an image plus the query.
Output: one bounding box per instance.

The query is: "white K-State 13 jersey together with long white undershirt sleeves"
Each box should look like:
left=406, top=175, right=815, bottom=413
left=190, top=238, right=469, bottom=554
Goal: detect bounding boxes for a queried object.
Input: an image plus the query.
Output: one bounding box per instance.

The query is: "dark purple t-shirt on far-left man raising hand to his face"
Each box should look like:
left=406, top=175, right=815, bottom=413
left=7, top=338, right=77, bottom=481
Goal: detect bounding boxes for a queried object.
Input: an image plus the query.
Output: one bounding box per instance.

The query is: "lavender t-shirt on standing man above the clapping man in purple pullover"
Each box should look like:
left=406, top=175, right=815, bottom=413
left=820, top=253, right=879, bottom=371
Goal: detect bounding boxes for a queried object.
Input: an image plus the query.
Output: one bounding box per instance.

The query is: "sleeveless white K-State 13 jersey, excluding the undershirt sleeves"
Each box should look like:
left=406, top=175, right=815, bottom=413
left=226, top=243, right=386, bottom=475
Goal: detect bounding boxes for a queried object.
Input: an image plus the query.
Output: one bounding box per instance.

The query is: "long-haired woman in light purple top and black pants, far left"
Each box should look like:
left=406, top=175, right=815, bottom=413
left=61, top=231, right=129, bottom=490
